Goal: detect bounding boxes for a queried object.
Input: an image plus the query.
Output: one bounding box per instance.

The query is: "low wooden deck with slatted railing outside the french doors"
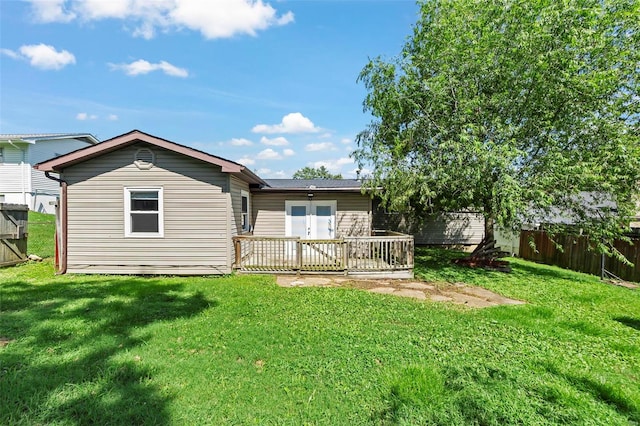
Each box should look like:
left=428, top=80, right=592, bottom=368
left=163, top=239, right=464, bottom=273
left=233, top=231, right=413, bottom=278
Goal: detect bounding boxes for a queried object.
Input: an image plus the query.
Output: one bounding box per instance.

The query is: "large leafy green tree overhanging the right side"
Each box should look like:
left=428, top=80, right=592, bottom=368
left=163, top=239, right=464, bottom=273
left=354, top=0, right=640, bottom=255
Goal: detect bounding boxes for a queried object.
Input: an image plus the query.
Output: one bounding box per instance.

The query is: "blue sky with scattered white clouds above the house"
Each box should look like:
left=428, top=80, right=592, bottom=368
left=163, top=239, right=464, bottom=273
left=0, top=0, right=418, bottom=178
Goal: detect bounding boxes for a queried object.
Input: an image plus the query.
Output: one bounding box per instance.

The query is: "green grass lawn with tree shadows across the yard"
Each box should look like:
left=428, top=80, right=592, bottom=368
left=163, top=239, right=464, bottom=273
left=0, top=241, right=640, bottom=425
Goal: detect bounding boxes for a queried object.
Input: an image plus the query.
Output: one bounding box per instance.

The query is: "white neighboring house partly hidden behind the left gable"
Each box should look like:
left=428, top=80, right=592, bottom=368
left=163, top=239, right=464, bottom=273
left=0, top=133, right=99, bottom=213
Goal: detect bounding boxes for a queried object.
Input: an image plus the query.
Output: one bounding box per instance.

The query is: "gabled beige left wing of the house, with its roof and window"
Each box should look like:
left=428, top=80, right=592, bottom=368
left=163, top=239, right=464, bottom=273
left=34, top=130, right=265, bottom=275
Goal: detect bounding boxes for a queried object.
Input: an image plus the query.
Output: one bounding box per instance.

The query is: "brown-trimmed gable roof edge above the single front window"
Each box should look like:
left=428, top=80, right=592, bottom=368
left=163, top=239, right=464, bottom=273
left=33, top=130, right=266, bottom=185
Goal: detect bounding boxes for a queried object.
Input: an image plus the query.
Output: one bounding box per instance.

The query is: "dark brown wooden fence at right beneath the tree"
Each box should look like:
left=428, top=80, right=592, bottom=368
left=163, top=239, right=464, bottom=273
left=520, top=231, right=640, bottom=281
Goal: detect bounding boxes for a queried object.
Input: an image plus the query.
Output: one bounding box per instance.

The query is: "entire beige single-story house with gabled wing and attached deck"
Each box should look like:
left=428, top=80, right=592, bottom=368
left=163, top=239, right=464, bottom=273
left=34, top=130, right=413, bottom=275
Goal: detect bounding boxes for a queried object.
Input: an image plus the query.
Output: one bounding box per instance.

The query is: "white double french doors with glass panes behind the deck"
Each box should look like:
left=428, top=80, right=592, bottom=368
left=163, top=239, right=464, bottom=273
left=285, top=200, right=337, bottom=240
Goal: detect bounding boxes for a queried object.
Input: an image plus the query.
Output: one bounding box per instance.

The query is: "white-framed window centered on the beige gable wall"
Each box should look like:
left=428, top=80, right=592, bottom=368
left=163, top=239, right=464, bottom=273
left=124, top=187, right=164, bottom=237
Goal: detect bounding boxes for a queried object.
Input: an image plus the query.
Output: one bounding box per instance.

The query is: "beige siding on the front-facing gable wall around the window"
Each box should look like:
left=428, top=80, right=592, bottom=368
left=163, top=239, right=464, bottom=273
left=63, top=146, right=231, bottom=274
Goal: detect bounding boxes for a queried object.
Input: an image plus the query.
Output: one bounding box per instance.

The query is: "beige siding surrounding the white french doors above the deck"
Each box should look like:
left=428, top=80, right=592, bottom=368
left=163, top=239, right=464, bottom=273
left=251, top=192, right=371, bottom=238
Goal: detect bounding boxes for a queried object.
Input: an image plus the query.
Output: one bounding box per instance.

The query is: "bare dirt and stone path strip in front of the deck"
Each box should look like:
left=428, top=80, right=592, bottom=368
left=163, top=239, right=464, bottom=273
left=277, top=275, right=525, bottom=308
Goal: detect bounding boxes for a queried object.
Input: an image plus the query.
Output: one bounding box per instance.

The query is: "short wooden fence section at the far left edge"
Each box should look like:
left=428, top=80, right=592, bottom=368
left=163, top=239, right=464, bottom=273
left=0, top=203, right=29, bottom=267
